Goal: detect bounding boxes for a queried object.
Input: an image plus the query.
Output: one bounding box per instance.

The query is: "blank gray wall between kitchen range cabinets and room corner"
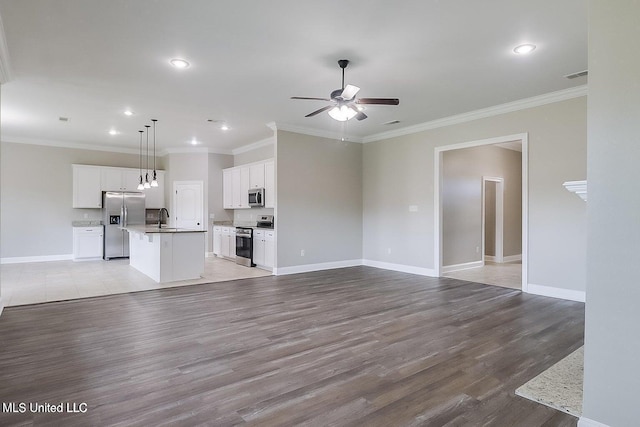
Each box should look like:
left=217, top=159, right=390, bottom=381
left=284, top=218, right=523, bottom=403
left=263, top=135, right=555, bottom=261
left=276, top=131, right=362, bottom=268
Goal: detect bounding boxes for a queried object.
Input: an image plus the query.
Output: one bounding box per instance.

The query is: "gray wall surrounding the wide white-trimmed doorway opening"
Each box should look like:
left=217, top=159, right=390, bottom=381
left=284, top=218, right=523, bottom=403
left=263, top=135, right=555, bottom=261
left=363, top=97, right=587, bottom=291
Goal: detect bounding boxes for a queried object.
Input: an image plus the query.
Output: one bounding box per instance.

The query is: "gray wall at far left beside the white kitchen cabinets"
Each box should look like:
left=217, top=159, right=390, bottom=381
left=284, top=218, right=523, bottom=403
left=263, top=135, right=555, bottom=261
left=0, top=142, right=138, bottom=258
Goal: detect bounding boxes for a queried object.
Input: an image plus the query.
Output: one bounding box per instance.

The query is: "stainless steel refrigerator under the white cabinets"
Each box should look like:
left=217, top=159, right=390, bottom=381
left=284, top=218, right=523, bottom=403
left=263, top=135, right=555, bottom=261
left=102, top=191, right=145, bottom=260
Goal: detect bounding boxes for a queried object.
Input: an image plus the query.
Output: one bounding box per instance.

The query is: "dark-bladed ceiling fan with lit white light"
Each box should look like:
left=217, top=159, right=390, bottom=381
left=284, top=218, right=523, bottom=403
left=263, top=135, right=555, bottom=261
left=291, top=59, right=400, bottom=122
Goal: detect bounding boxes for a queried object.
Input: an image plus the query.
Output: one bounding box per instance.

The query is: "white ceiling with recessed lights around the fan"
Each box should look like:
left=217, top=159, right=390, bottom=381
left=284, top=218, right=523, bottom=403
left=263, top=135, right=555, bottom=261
left=0, top=0, right=587, bottom=152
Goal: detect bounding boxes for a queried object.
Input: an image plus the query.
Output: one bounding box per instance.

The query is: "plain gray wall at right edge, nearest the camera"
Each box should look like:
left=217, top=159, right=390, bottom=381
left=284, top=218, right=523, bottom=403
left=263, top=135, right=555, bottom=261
left=583, top=0, right=640, bottom=426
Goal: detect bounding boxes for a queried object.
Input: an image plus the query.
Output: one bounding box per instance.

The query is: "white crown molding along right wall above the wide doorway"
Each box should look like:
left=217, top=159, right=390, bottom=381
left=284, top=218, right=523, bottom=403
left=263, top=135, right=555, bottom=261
left=362, top=85, right=587, bottom=143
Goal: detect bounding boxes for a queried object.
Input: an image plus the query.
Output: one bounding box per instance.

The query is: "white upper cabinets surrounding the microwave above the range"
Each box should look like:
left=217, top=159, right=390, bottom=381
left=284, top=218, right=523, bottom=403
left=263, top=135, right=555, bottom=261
left=222, top=159, right=275, bottom=209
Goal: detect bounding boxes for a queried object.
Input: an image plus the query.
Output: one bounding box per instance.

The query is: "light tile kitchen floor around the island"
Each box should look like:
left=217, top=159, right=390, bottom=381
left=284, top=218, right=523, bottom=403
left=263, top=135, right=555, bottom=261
left=0, top=257, right=271, bottom=307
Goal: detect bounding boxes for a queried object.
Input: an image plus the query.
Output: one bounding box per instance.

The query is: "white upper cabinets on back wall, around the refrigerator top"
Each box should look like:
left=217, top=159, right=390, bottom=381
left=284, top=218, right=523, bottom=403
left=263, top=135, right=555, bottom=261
left=73, top=165, right=165, bottom=209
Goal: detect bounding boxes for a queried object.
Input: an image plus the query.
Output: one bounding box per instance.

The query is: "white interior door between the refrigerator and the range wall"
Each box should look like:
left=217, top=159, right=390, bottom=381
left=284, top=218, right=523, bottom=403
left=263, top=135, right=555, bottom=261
left=172, top=181, right=204, bottom=230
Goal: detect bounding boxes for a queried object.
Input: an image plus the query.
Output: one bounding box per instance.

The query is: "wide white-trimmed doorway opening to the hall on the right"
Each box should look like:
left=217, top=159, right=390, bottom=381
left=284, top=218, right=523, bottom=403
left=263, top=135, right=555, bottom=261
left=434, top=133, right=528, bottom=292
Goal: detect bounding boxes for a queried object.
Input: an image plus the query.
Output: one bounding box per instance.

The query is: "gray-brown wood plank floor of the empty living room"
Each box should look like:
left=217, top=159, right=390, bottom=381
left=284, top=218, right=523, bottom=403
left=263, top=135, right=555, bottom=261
left=0, top=267, right=584, bottom=427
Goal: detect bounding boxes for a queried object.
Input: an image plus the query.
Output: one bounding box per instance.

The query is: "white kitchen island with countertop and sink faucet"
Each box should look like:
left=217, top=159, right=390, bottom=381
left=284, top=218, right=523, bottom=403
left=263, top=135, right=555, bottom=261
left=125, top=226, right=205, bottom=283
